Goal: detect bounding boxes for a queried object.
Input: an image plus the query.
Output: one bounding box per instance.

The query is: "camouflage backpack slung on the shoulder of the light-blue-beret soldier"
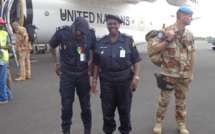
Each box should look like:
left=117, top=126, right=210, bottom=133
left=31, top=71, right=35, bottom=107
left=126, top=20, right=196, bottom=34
left=145, top=30, right=163, bottom=67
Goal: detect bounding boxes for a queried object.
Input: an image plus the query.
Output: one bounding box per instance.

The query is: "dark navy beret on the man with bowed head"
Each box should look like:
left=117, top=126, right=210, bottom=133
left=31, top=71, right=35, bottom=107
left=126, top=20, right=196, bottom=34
left=74, top=17, right=90, bottom=34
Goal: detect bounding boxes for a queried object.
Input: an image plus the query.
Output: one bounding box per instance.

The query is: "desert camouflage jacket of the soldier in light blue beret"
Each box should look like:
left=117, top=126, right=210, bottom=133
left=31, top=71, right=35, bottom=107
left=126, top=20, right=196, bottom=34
left=153, top=24, right=196, bottom=78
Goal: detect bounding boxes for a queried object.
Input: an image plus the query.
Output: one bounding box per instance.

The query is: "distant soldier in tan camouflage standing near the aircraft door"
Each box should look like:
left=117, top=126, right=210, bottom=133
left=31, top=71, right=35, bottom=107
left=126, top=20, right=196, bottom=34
left=12, top=22, right=32, bottom=81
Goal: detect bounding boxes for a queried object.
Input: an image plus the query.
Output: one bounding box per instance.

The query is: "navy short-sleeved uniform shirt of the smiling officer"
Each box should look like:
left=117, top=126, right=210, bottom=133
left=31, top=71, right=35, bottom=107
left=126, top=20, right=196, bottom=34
left=93, top=32, right=141, bottom=72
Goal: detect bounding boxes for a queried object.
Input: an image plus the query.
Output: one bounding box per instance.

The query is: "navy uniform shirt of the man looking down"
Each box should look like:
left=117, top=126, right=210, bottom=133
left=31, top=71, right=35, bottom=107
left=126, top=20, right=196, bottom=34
left=49, top=26, right=96, bottom=67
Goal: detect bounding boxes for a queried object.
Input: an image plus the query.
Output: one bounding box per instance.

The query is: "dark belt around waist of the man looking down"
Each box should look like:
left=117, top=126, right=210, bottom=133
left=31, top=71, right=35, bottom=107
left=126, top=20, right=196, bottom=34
left=61, top=63, right=88, bottom=72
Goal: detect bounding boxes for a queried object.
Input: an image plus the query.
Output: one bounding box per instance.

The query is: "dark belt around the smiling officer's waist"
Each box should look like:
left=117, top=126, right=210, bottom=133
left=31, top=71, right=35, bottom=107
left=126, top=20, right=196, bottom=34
left=101, top=68, right=132, bottom=77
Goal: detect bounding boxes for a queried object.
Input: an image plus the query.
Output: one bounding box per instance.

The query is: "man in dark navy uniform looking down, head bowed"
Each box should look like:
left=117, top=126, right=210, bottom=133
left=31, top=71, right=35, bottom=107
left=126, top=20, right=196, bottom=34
left=49, top=17, right=96, bottom=134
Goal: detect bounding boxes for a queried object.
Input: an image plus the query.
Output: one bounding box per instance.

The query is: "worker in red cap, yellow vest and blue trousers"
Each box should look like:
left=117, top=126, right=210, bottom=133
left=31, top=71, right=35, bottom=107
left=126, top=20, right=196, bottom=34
left=0, top=17, right=12, bottom=105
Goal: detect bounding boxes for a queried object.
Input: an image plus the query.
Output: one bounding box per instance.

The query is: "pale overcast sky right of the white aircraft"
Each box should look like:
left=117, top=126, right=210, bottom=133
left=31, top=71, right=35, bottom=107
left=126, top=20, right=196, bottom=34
left=188, top=0, right=215, bottom=37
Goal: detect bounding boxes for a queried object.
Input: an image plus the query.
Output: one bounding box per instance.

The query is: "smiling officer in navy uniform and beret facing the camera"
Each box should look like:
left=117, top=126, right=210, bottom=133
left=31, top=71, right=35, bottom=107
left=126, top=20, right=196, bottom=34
left=91, top=14, right=141, bottom=134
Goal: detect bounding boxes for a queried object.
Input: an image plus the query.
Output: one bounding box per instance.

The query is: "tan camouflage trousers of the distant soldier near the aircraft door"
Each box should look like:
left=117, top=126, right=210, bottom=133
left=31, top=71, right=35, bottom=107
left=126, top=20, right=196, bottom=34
left=18, top=51, right=31, bottom=78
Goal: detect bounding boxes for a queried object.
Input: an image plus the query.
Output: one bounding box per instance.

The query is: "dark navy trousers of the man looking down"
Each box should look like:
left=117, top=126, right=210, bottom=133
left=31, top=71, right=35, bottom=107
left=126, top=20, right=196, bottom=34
left=60, top=74, right=92, bottom=132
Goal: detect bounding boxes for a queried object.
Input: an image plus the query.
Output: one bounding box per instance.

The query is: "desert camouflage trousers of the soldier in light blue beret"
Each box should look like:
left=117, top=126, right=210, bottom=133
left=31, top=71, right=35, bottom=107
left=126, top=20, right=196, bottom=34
left=156, top=76, right=189, bottom=126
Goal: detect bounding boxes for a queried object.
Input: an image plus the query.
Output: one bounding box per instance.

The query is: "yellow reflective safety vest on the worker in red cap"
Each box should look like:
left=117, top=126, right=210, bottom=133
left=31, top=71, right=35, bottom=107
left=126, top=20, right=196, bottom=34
left=0, top=30, right=9, bottom=62
